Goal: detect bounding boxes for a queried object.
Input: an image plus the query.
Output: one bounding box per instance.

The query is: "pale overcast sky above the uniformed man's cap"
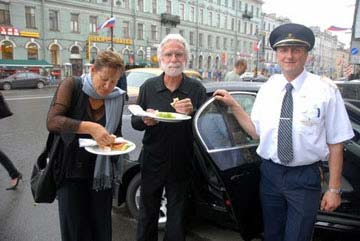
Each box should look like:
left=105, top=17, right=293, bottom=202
left=262, top=0, right=356, bottom=46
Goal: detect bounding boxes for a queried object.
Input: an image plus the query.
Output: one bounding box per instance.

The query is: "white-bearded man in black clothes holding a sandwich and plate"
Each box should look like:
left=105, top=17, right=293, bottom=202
left=131, top=34, right=206, bottom=241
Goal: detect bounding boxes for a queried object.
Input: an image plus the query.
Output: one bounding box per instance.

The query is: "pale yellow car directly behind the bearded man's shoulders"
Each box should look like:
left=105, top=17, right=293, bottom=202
left=125, top=68, right=202, bottom=104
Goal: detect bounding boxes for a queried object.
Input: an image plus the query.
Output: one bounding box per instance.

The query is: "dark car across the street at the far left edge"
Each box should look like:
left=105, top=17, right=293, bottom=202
left=0, top=72, right=49, bottom=90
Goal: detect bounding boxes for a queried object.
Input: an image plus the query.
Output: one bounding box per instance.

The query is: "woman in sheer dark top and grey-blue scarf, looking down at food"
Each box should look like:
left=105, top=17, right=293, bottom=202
left=47, top=51, right=125, bottom=241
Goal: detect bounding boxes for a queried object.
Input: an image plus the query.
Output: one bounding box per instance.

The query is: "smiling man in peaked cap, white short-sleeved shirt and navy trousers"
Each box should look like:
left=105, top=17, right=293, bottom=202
left=214, top=23, right=354, bottom=241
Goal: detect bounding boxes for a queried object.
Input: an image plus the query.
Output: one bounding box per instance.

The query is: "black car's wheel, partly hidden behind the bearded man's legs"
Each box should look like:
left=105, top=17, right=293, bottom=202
left=126, top=173, right=167, bottom=229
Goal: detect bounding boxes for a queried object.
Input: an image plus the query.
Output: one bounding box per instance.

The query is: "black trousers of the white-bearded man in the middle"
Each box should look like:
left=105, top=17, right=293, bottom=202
left=136, top=169, right=189, bottom=241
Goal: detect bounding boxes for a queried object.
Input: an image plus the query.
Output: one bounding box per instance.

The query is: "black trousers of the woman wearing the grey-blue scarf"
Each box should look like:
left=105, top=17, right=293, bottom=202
left=57, top=179, right=112, bottom=241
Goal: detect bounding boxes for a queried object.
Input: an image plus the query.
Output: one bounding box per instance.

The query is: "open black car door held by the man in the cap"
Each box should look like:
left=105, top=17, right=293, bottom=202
left=193, top=92, right=262, bottom=240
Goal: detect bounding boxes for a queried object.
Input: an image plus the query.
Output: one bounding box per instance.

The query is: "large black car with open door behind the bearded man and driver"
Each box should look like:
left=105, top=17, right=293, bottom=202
left=116, top=82, right=360, bottom=241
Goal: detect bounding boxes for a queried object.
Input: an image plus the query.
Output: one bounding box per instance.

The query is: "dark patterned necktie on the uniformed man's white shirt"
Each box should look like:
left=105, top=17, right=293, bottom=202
left=278, top=83, right=294, bottom=165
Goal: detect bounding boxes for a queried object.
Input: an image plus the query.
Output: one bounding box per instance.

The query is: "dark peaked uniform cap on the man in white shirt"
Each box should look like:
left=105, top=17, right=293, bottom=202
left=269, top=23, right=315, bottom=51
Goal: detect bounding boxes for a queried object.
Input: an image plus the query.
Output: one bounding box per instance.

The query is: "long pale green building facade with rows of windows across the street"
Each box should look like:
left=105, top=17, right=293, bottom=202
left=0, top=0, right=352, bottom=77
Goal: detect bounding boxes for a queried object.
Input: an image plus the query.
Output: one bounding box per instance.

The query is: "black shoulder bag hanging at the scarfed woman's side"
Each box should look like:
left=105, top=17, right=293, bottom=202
left=30, top=79, right=81, bottom=203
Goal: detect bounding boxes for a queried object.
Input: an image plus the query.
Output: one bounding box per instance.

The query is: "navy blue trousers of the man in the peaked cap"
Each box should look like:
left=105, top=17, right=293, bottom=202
left=260, top=160, right=321, bottom=241
